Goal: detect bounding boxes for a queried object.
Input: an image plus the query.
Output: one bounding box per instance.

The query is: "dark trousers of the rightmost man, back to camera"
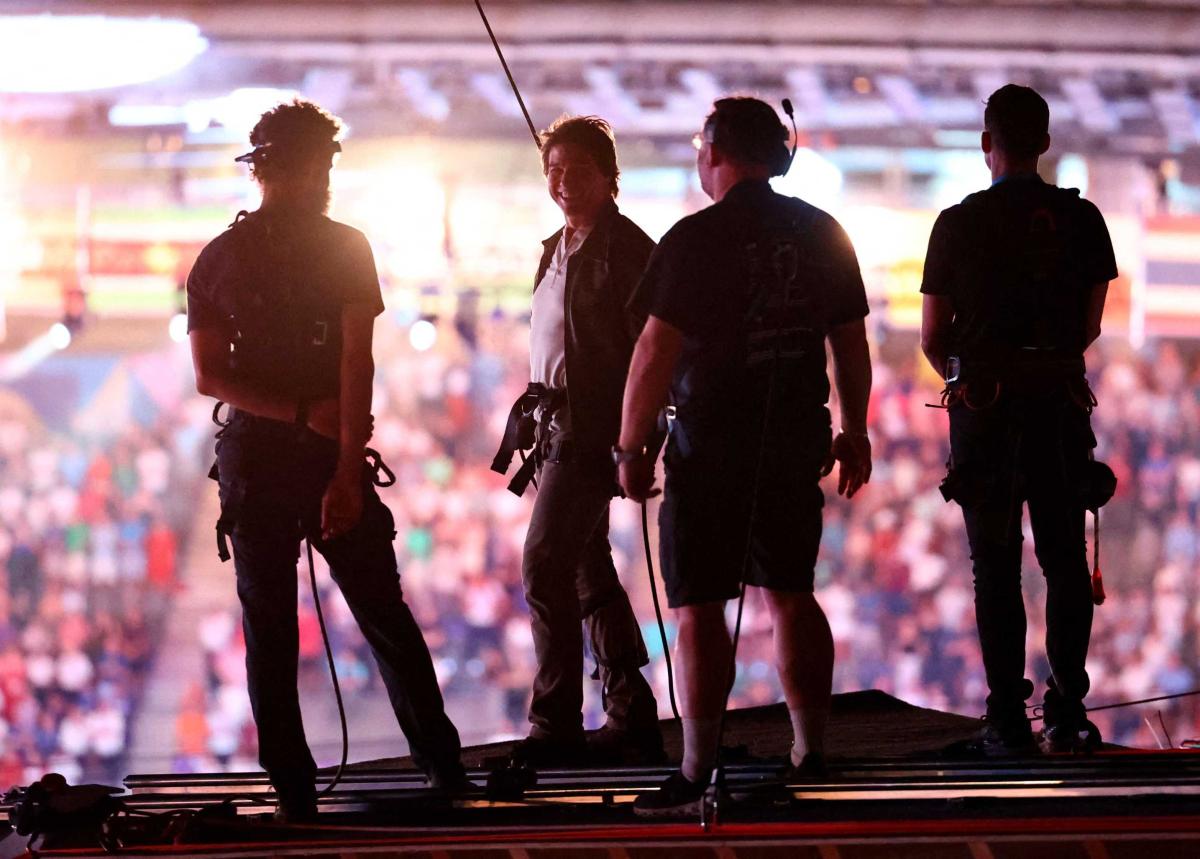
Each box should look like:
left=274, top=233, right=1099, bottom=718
left=950, top=392, right=1096, bottom=719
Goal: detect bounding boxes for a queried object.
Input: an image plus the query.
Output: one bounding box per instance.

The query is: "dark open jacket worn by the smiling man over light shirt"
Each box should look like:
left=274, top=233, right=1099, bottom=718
left=534, top=203, right=654, bottom=455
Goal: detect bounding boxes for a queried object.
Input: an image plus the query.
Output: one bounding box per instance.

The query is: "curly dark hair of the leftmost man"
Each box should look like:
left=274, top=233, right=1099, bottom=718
left=250, top=98, right=343, bottom=182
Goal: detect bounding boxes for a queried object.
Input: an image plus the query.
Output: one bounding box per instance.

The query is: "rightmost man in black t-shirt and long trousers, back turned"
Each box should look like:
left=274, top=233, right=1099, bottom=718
left=920, top=84, right=1117, bottom=756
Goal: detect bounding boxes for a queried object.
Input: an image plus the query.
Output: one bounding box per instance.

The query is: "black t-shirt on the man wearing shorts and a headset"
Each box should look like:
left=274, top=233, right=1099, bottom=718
left=631, top=181, right=868, bottom=453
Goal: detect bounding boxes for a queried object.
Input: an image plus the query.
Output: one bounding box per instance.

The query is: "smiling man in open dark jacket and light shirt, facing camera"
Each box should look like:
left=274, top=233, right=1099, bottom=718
left=499, top=116, right=664, bottom=765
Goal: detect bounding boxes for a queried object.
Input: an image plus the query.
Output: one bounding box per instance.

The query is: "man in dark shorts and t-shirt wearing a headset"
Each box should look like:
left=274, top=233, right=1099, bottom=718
left=613, top=98, right=871, bottom=816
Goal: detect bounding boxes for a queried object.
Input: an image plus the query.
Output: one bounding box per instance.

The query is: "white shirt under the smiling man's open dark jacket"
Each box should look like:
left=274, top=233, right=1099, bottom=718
left=529, top=229, right=592, bottom=432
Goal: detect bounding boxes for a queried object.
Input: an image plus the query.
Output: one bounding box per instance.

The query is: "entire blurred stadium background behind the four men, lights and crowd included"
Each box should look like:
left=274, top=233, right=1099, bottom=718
left=0, top=0, right=1200, bottom=789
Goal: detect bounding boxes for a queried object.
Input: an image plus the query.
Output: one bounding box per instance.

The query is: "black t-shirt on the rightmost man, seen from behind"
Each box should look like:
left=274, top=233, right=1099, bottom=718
left=920, top=175, right=1117, bottom=360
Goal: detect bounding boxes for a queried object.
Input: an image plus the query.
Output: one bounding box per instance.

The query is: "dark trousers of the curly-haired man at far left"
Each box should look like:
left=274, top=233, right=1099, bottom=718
left=217, top=419, right=460, bottom=793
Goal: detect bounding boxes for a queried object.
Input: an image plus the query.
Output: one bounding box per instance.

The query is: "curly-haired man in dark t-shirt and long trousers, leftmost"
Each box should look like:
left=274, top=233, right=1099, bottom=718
left=187, top=101, right=464, bottom=822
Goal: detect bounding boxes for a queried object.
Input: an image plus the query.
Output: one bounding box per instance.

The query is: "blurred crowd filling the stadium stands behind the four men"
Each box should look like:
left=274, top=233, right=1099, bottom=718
left=0, top=317, right=1200, bottom=787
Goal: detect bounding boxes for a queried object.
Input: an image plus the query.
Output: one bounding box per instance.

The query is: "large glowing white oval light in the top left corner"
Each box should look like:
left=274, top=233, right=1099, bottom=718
left=0, top=14, right=209, bottom=92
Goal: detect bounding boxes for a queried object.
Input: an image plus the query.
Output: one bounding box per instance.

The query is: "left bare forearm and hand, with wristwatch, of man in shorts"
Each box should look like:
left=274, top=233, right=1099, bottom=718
left=618, top=316, right=683, bottom=501
